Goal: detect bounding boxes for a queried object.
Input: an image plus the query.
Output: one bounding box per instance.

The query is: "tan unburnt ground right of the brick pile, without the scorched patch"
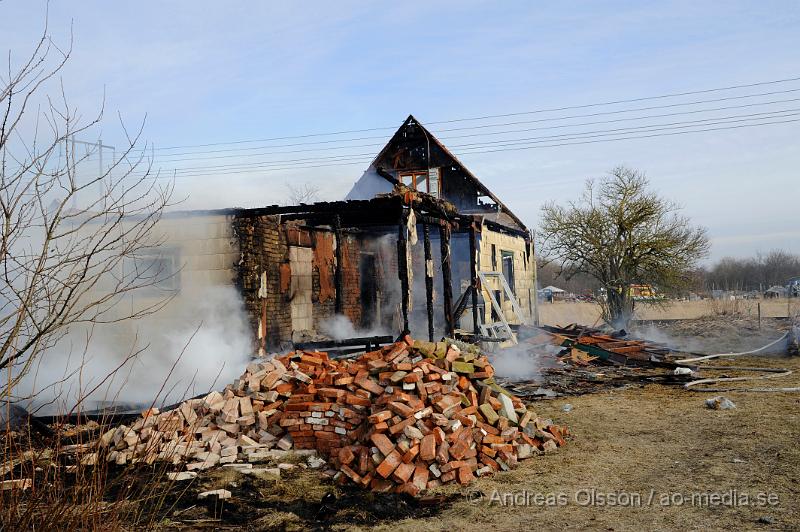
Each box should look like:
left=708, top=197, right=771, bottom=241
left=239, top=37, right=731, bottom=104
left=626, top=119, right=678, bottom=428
left=368, top=357, right=800, bottom=530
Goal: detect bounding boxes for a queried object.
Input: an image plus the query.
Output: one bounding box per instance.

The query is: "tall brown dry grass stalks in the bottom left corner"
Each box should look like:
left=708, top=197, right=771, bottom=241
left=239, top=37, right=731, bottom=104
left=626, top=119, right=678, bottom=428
left=0, top=416, right=197, bottom=530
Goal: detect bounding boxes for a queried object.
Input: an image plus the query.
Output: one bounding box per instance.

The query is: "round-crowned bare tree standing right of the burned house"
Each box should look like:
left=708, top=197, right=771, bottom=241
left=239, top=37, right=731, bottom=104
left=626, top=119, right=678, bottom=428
left=539, top=167, right=709, bottom=327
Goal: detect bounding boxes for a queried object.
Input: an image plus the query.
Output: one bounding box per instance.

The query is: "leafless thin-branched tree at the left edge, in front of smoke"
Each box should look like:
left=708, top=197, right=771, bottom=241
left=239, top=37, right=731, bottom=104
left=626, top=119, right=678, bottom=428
left=0, top=14, right=172, bottom=400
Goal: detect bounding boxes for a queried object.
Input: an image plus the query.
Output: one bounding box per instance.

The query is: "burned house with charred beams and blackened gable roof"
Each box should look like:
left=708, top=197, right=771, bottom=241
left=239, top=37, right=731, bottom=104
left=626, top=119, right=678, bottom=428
left=126, top=117, right=536, bottom=351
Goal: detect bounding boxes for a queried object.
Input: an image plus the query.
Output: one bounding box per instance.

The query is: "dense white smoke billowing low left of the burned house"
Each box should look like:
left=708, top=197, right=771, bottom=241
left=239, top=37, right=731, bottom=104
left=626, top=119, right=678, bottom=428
left=15, top=286, right=251, bottom=414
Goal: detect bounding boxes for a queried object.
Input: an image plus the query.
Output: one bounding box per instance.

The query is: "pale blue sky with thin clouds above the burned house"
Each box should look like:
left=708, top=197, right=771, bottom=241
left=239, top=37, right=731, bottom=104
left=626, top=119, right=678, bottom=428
left=0, top=0, right=800, bottom=259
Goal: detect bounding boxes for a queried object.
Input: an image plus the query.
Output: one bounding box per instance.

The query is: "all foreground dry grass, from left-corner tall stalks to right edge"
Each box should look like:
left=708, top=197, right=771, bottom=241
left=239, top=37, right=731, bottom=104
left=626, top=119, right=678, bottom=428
left=6, top=342, right=800, bottom=532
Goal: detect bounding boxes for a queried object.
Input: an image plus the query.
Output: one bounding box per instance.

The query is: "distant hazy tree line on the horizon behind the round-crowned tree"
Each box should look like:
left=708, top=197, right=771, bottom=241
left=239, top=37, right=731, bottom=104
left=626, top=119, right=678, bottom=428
left=538, top=250, right=800, bottom=295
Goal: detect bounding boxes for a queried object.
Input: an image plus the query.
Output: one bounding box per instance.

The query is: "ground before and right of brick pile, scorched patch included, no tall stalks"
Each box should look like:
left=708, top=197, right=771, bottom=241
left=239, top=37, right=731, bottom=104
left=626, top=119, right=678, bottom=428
left=152, top=357, right=800, bottom=532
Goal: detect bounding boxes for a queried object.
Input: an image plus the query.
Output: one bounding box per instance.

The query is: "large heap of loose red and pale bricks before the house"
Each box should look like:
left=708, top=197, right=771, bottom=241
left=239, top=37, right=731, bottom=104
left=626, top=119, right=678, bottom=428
left=101, top=338, right=567, bottom=495
